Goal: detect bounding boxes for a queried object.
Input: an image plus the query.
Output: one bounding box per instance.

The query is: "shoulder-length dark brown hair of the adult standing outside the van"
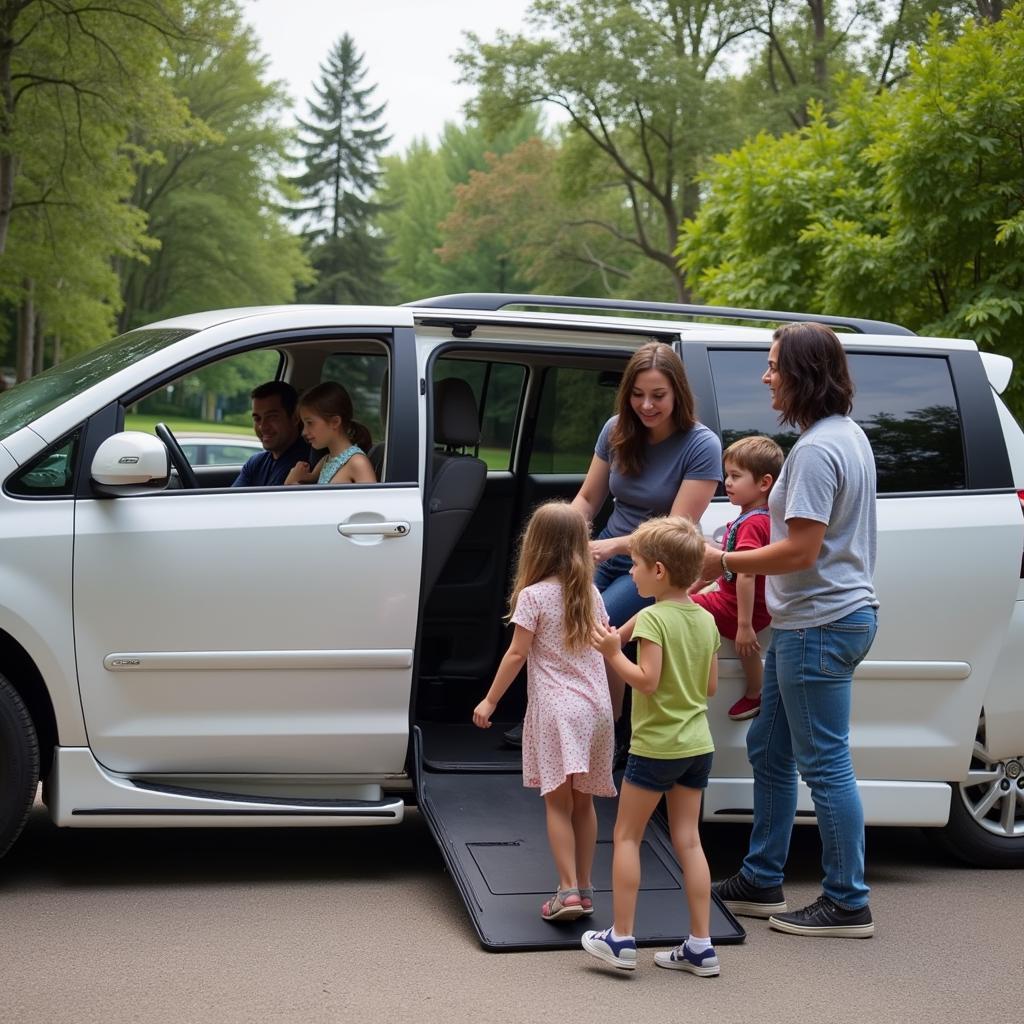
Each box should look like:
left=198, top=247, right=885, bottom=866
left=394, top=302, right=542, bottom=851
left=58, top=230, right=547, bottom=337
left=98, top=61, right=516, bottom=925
left=772, top=323, right=853, bottom=430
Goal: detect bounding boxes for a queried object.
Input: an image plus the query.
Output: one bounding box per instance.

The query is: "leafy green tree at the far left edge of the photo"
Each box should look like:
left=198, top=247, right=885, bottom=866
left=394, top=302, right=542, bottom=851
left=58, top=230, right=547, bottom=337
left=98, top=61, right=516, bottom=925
left=0, top=0, right=188, bottom=379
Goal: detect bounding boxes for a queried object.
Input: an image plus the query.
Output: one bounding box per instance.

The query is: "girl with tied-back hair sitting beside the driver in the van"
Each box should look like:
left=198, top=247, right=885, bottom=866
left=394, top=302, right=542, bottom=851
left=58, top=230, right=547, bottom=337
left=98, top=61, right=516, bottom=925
left=285, top=381, right=377, bottom=483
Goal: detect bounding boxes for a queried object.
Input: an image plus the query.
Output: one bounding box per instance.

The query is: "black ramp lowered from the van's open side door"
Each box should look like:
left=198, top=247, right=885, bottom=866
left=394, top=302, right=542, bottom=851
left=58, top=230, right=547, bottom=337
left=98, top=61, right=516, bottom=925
left=414, top=729, right=746, bottom=952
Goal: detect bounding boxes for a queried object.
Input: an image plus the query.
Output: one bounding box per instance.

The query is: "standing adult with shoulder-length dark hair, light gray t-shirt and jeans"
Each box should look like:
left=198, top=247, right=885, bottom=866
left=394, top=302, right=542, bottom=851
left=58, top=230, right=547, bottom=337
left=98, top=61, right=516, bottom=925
left=705, top=324, right=879, bottom=938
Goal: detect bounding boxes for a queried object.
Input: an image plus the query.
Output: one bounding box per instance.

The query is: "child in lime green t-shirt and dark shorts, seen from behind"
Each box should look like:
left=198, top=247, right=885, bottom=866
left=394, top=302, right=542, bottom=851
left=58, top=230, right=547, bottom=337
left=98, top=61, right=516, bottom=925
left=583, top=516, right=721, bottom=978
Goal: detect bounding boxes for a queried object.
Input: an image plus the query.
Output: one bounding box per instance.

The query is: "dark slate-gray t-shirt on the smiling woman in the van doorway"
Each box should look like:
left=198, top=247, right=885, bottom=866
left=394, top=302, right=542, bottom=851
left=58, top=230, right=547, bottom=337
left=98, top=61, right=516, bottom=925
left=594, top=416, right=722, bottom=537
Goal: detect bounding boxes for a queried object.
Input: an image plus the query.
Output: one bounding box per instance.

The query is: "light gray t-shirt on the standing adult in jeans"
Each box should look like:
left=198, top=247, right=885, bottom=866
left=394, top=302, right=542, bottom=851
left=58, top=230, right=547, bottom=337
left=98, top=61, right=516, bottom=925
left=765, top=416, right=879, bottom=630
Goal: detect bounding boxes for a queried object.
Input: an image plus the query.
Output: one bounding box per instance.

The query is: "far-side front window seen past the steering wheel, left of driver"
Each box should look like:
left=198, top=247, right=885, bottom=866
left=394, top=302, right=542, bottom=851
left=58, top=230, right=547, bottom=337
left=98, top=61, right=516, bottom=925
left=125, top=350, right=281, bottom=466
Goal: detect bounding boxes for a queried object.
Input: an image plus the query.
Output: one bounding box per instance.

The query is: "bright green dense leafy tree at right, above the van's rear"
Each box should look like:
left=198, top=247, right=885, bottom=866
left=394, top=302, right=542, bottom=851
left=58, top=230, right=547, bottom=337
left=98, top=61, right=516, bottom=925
left=678, top=14, right=1024, bottom=414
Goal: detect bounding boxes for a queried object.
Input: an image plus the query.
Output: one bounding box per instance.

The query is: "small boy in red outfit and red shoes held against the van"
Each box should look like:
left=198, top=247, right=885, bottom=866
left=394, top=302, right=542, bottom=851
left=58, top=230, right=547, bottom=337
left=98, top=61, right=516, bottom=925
left=690, top=435, right=784, bottom=722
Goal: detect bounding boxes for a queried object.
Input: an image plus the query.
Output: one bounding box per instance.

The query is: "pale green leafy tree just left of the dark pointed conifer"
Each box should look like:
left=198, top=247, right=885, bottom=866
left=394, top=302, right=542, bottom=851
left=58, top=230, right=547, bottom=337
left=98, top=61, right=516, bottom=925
left=120, top=0, right=311, bottom=331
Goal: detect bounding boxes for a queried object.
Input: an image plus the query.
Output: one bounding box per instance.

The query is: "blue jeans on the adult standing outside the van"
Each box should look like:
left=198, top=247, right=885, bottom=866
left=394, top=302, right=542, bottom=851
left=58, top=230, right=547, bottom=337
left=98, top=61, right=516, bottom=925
left=742, top=607, right=879, bottom=910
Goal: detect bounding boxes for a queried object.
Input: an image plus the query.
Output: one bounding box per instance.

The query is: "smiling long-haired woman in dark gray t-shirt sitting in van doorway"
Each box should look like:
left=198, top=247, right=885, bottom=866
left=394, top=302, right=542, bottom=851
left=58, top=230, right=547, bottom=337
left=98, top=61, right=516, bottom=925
left=572, top=341, right=722, bottom=626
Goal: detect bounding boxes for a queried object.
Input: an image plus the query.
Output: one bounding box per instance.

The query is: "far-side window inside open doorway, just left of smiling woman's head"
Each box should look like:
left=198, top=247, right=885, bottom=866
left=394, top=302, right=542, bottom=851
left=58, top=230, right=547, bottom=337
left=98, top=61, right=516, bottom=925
left=529, top=367, right=618, bottom=474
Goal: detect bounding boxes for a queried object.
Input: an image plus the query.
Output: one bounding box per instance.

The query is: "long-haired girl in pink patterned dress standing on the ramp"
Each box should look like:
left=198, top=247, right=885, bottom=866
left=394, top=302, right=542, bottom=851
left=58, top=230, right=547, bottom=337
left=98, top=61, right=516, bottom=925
left=473, top=502, right=615, bottom=921
